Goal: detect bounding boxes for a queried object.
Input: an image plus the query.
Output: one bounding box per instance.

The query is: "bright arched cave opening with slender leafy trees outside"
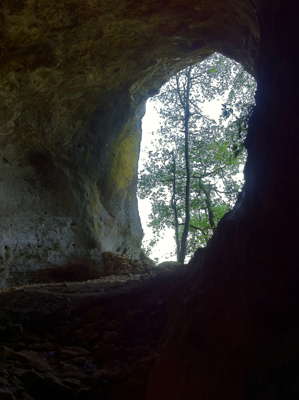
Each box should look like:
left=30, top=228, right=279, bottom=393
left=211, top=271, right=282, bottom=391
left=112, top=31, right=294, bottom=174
left=138, top=53, right=256, bottom=263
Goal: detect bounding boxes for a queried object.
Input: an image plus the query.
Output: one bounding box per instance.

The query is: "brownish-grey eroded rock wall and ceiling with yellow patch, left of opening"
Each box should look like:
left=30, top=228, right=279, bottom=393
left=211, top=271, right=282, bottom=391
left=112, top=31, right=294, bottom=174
left=0, top=0, right=258, bottom=285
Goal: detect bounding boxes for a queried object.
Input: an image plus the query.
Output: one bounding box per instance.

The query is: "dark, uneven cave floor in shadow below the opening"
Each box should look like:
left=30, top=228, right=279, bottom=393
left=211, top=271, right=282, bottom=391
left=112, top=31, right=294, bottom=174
left=0, top=267, right=186, bottom=400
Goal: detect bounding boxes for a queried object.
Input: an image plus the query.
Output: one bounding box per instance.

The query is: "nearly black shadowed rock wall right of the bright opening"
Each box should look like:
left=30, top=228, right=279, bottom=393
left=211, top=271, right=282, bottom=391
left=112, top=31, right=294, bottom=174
left=148, top=1, right=299, bottom=400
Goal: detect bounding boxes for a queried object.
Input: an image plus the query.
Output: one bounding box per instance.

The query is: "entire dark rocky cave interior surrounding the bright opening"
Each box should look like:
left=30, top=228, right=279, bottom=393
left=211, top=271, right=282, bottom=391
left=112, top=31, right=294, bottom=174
left=0, top=0, right=299, bottom=400
